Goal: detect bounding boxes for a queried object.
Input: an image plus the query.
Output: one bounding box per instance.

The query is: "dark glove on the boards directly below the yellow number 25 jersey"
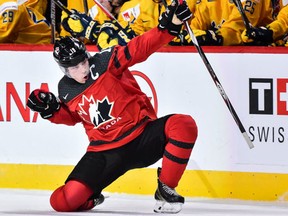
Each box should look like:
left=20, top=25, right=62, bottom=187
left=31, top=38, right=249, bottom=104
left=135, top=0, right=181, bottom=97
left=241, top=26, right=273, bottom=45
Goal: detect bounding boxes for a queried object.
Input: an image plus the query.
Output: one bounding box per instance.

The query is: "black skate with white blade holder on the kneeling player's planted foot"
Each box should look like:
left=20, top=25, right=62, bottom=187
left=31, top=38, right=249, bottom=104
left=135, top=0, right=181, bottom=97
left=154, top=179, right=185, bottom=213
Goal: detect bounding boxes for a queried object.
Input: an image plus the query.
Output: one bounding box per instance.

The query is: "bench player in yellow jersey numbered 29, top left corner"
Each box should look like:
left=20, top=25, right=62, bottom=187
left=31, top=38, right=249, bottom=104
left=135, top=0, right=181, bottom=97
left=0, top=0, right=51, bottom=44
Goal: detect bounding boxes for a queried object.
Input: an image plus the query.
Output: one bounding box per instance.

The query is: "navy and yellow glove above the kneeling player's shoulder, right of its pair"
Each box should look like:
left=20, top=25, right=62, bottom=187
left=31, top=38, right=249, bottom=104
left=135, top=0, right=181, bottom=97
left=97, top=20, right=136, bottom=50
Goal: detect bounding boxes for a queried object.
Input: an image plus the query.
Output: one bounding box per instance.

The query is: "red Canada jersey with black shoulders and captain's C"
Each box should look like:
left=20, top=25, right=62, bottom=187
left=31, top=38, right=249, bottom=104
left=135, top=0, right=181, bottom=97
left=49, top=28, right=173, bottom=151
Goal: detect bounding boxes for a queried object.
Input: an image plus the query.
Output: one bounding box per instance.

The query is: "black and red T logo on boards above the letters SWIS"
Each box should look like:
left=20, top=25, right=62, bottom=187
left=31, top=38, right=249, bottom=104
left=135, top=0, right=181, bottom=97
left=249, top=78, right=288, bottom=115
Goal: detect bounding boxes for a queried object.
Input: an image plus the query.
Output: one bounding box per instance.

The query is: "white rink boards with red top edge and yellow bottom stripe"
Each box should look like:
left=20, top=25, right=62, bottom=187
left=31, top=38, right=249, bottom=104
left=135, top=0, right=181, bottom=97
left=0, top=45, right=288, bottom=201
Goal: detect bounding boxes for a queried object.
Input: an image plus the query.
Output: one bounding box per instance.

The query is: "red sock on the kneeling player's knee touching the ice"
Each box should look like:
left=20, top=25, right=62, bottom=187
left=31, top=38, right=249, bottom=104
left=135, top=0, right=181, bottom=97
left=50, top=180, right=94, bottom=212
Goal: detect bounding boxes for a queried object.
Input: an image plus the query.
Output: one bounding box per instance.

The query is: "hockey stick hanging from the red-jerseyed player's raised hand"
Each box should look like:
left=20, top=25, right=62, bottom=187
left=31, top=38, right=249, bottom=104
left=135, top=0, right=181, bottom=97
left=162, top=0, right=254, bottom=149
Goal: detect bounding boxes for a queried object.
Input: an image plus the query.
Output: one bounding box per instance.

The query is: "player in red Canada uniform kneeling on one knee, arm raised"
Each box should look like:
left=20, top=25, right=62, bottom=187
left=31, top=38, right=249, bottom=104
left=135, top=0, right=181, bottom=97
left=27, top=1, right=197, bottom=213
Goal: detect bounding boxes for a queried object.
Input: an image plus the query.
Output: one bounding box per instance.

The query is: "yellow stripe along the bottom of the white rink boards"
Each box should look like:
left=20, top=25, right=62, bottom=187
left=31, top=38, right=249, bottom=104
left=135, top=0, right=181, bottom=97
left=0, top=164, right=288, bottom=201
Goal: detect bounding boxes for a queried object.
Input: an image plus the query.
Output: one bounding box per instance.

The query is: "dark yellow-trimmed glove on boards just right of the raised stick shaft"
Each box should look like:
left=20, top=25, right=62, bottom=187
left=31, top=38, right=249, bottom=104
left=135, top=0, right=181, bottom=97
left=196, top=30, right=223, bottom=46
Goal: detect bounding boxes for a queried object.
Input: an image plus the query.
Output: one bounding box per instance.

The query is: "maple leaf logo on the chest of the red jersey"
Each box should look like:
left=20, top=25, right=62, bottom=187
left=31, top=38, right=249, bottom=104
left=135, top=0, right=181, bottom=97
left=78, top=95, right=115, bottom=128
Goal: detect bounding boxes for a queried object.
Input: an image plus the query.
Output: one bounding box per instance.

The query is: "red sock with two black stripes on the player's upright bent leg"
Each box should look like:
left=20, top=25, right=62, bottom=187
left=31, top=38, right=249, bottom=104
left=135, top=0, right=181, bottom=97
left=159, top=114, right=198, bottom=188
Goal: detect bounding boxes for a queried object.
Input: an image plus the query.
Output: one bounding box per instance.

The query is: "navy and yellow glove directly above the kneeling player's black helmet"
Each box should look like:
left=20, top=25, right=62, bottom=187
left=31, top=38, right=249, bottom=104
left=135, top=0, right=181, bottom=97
left=61, top=9, right=100, bottom=43
